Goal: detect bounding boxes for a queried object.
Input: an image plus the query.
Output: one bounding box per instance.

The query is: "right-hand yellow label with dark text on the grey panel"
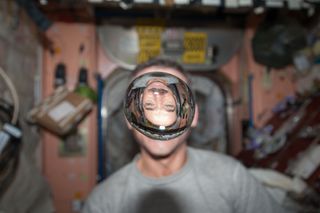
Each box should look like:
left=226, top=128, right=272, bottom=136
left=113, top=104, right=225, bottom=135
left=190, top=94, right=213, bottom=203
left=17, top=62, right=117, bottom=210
left=182, top=32, right=208, bottom=64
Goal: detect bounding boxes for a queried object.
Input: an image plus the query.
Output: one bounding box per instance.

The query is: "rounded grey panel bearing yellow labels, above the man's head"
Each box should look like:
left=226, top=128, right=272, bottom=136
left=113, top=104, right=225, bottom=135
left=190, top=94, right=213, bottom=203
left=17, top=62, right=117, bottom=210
left=98, top=23, right=243, bottom=71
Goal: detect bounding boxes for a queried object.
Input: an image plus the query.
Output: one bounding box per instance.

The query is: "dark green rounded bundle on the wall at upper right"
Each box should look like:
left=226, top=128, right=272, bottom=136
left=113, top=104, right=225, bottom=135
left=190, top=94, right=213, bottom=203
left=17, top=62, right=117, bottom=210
left=252, top=13, right=307, bottom=68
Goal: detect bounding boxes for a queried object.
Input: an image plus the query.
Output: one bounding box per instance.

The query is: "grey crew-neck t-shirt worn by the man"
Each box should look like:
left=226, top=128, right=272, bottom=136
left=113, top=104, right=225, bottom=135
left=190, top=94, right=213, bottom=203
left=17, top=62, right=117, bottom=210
left=82, top=148, right=284, bottom=213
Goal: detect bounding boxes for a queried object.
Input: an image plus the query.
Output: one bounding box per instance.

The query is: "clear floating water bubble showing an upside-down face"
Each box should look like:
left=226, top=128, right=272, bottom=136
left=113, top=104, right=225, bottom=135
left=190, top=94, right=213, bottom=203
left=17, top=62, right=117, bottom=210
left=124, top=72, right=195, bottom=140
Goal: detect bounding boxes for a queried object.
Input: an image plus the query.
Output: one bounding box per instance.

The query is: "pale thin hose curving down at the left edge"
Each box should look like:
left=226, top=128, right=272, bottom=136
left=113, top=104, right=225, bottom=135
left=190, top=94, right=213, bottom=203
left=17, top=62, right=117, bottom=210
left=0, top=67, right=20, bottom=125
